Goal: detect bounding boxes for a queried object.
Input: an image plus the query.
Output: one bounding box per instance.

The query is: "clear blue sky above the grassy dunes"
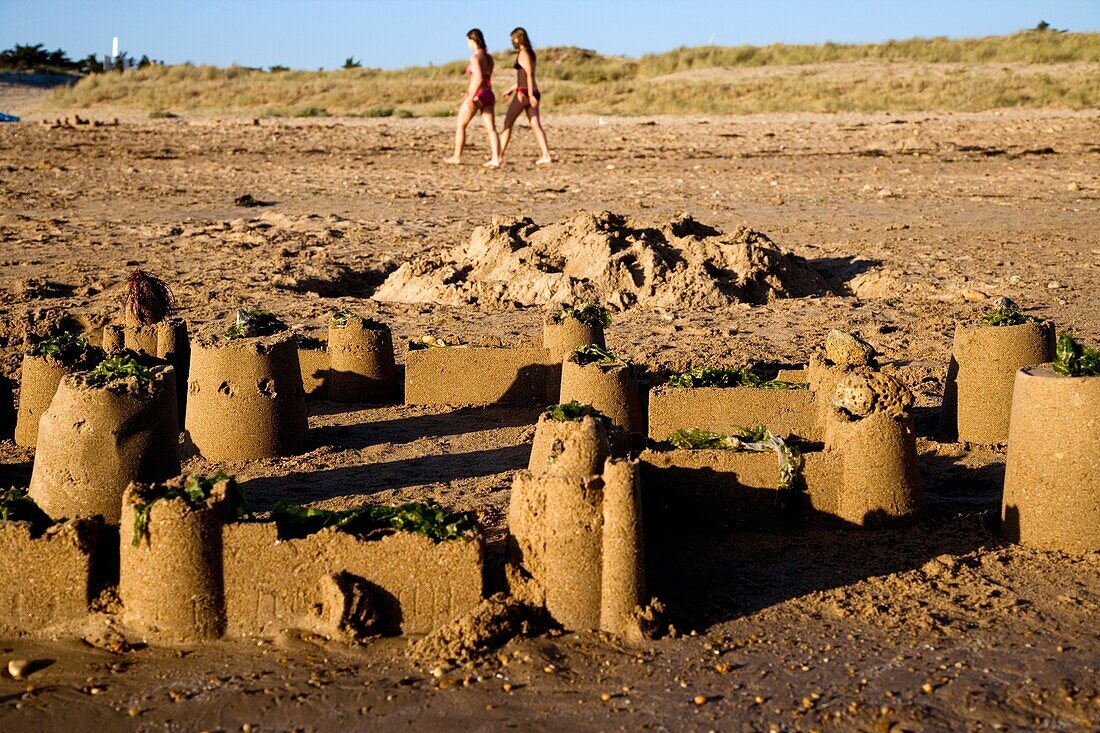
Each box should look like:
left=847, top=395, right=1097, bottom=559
left=0, top=0, right=1100, bottom=68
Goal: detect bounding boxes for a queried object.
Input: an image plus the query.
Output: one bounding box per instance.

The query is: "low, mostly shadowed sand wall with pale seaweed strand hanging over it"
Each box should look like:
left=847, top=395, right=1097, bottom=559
left=638, top=449, right=842, bottom=529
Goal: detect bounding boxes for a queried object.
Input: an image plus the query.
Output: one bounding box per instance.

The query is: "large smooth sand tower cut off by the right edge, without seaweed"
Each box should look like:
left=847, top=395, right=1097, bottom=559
left=1001, top=367, right=1100, bottom=553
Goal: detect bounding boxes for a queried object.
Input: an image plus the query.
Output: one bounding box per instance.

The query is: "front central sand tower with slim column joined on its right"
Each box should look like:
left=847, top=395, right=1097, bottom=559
left=508, top=430, right=645, bottom=641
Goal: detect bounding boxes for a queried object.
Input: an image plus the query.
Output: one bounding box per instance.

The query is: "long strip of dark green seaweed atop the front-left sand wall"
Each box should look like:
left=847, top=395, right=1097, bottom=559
left=272, top=502, right=480, bottom=543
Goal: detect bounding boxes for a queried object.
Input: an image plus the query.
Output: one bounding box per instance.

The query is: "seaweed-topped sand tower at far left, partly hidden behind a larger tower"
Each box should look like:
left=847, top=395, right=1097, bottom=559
left=15, top=331, right=103, bottom=448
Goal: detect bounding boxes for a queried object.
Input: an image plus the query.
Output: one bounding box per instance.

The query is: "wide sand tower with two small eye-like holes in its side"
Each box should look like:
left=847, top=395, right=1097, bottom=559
left=185, top=333, right=309, bottom=461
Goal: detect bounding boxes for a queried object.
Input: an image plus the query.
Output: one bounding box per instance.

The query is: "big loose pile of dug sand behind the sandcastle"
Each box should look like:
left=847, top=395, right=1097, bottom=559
left=373, top=211, right=827, bottom=310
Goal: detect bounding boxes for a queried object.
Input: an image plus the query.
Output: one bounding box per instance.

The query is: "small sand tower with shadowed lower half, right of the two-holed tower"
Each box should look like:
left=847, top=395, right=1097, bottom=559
left=328, top=316, right=397, bottom=402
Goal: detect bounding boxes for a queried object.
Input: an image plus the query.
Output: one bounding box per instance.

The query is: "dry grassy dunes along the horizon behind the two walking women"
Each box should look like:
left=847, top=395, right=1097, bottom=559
left=47, top=31, right=1100, bottom=117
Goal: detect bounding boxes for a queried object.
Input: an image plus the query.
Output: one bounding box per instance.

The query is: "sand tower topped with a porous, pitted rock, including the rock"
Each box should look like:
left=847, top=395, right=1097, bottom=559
left=825, top=372, right=924, bottom=528
